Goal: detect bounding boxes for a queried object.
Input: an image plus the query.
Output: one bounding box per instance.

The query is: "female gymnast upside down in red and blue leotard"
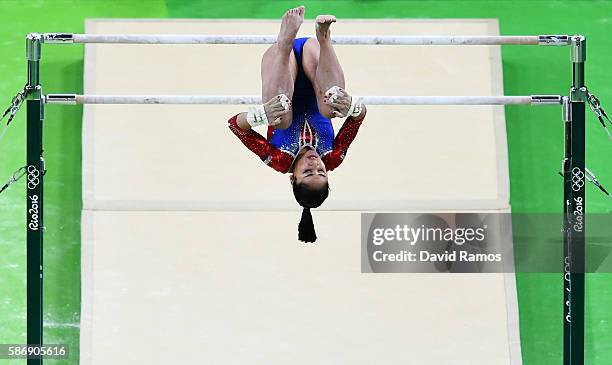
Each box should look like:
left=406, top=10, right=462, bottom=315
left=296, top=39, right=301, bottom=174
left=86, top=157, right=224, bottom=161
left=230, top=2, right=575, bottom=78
left=229, top=6, right=366, bottom=242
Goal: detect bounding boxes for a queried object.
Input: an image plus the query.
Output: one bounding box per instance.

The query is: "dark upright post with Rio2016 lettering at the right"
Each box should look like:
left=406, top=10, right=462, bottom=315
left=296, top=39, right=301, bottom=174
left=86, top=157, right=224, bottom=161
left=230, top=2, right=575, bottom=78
left=563, top=35, right=587, bottom=365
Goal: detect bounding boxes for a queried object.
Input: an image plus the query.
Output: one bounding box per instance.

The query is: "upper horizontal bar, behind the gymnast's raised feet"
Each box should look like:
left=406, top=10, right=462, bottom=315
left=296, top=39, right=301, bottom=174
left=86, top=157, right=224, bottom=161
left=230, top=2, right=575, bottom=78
left=42, top=33, right=573, bottom=46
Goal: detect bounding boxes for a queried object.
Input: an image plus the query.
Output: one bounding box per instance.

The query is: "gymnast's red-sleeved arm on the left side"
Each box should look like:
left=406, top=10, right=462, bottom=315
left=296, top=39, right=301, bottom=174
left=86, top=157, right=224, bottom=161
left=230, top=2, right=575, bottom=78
left=228, top=113, right=292, bottom=173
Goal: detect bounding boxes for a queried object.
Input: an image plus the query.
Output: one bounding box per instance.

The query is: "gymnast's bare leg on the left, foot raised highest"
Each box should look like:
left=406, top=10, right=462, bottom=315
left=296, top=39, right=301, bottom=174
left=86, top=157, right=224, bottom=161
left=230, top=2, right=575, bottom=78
left=261, top=6, right=304, bottom=129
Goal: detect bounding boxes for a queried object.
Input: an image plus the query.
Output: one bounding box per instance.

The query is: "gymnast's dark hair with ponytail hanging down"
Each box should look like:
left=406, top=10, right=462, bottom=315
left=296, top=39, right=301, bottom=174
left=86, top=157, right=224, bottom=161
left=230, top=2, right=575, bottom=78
left=291, top=180, right=329, bottom=242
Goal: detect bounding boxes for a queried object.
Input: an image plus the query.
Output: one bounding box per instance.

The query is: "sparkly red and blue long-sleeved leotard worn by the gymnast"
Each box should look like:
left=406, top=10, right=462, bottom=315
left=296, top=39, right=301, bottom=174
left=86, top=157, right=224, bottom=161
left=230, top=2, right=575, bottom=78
left=228, top=38, right=364, bottom=173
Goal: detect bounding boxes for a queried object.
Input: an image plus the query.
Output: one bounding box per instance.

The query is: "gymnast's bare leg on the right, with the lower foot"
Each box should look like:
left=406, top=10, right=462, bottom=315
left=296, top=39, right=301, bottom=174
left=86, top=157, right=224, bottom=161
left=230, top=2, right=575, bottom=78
left=302, top=15, right=345, bottom=118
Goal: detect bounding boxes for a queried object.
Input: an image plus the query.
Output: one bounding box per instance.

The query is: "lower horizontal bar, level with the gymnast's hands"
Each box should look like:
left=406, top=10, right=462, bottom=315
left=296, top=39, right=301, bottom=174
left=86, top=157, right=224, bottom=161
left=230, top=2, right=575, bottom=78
left=44, top=94, right=561, bottom=105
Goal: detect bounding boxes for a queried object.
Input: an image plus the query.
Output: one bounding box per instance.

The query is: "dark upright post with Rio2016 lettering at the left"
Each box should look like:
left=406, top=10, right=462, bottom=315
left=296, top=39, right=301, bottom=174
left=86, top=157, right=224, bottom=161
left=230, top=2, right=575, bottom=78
left=26, top=33, right=45, bottom=365
